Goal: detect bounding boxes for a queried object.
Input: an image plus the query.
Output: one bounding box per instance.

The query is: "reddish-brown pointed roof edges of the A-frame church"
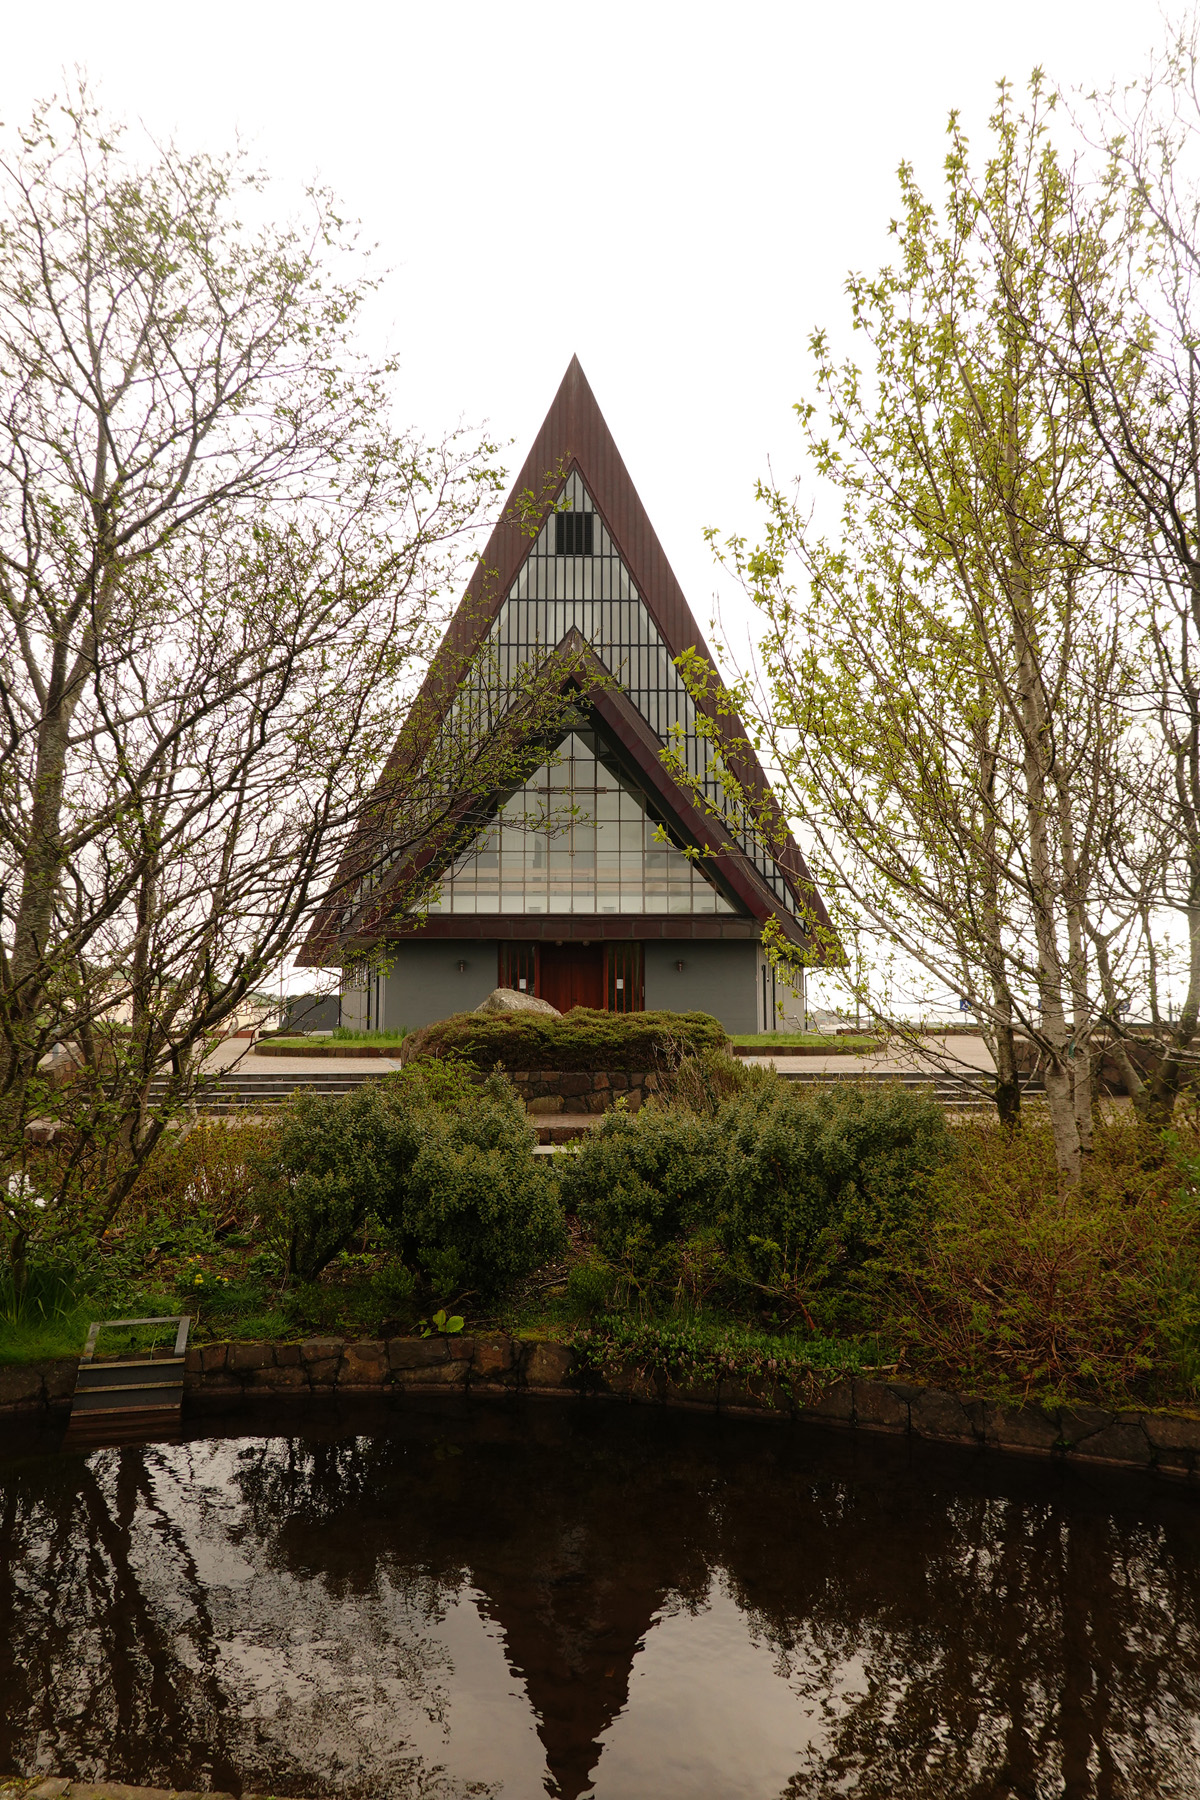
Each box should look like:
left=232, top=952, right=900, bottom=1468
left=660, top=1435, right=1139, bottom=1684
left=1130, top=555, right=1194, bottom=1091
left=299, top=356, right=835, bottom=967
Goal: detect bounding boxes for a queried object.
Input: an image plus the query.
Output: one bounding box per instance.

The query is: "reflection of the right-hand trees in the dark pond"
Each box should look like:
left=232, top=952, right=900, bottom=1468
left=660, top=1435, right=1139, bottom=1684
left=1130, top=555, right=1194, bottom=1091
left=721, top=1467, right=1200, bottom=1800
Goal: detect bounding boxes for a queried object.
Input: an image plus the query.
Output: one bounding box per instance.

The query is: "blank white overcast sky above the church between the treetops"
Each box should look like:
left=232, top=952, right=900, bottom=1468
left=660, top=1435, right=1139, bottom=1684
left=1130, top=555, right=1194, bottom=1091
left=0, top=0, right=1164, bottom=1008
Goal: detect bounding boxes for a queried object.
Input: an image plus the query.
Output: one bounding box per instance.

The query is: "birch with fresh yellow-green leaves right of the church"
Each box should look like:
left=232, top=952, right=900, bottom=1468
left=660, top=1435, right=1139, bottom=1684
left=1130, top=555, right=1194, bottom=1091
left=708, top=76, right=1162, bottom=1179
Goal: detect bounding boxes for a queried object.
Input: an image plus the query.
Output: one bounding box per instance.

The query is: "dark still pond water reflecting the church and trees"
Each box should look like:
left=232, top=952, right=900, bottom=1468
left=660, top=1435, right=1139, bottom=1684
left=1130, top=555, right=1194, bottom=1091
left=0, top=1404, right=1200, bottom=1800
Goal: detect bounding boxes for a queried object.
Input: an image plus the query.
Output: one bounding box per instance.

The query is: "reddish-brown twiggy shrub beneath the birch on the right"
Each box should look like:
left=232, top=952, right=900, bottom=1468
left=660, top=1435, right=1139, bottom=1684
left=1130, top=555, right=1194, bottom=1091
left=894, top=1116, right=1200, bottom=1406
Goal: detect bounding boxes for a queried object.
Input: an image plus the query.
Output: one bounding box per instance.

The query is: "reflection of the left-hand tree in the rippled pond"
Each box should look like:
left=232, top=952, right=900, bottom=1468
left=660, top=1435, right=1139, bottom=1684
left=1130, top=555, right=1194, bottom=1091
left=0, top=1440, right=474, bottom=1800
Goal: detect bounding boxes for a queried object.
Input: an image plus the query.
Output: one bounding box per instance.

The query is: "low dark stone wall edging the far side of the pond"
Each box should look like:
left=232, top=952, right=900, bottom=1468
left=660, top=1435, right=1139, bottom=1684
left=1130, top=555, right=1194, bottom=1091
left=0, top=1332, right=1200, bottom=1480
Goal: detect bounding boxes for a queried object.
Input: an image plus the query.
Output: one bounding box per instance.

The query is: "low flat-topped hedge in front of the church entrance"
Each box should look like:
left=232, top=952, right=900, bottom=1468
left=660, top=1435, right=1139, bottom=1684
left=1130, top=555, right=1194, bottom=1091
left=401, top=1006, right=729, bottom=1071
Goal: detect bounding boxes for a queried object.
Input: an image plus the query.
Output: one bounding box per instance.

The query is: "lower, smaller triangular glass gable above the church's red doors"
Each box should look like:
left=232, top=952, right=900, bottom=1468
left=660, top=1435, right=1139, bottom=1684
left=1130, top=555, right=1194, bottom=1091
left=430, top=731, right=734, bottom=914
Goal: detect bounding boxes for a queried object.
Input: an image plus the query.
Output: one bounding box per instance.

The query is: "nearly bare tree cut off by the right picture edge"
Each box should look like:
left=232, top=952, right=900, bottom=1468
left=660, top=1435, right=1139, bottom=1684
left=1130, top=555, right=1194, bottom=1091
left=1025, top=22, right=1200, bottom=1125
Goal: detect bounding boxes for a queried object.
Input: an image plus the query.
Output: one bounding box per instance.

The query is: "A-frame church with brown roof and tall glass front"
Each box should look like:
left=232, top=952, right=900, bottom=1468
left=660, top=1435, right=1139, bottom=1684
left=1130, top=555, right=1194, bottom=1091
left=299, top=358, right=833, bottom=1031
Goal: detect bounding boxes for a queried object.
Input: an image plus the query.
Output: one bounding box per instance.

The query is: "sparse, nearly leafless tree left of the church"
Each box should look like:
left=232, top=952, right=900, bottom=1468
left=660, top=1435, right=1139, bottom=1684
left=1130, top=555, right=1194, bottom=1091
left=0, top=88, right=500, bottom=1258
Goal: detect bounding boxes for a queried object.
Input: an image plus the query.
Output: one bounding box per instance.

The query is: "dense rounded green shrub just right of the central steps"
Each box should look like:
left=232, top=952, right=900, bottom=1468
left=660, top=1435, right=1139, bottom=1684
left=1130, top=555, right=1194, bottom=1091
left=561, top=1076, right=954, bottom=1323
